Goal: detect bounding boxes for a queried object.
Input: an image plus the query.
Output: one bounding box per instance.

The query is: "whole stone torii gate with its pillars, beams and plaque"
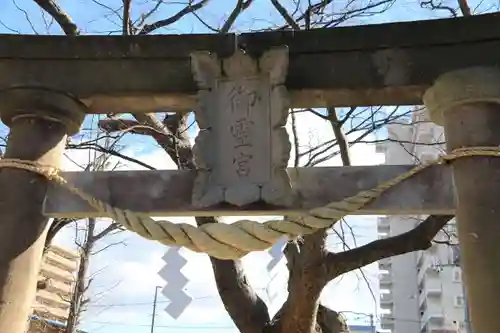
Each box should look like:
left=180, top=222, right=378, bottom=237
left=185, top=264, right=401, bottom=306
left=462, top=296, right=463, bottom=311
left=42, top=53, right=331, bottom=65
left=0, top=14, right=500, bottom=333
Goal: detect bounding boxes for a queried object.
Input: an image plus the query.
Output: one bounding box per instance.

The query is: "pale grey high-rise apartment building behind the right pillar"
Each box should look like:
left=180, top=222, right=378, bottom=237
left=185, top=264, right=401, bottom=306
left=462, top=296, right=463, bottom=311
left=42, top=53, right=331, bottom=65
left=377, top=111, right=470, bottom=333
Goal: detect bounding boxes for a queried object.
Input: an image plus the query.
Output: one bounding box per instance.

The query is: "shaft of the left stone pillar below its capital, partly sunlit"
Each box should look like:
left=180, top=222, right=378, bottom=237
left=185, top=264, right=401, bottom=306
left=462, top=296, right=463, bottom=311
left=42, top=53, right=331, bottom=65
left=0, top=118, right=67, bottom=333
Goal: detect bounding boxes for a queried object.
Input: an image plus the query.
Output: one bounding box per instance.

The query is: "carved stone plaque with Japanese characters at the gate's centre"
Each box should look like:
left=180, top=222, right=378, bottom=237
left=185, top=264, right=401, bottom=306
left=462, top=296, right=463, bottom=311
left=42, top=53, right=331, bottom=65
left=191, top=48, right=291, bottom=207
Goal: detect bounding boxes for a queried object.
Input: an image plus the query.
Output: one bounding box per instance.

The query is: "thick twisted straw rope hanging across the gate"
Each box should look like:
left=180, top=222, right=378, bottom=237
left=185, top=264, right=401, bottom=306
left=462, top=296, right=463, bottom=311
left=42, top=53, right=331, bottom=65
left=0, top=147, right=500, bottom=259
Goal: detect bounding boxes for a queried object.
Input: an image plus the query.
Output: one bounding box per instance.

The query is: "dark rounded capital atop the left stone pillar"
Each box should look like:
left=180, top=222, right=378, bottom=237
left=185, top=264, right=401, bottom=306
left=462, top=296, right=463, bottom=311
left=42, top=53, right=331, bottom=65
left=0, top=87, right=86, bottom=135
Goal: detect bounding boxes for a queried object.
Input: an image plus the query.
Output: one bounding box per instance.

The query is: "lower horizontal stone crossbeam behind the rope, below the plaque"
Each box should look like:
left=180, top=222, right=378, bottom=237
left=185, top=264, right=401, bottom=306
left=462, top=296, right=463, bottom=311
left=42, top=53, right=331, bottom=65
left=45, top=165, right=455, bottom=218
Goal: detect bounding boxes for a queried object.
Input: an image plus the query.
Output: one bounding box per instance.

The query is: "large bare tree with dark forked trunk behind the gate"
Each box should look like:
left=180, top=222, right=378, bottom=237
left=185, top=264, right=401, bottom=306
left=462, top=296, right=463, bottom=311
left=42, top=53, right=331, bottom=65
left=27, top=0, right=458, bottom=333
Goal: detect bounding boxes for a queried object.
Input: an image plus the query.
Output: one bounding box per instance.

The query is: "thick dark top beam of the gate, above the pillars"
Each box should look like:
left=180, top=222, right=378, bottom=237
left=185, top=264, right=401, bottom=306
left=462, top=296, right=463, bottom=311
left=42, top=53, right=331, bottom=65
left=0, top=13, right=500, bottom=114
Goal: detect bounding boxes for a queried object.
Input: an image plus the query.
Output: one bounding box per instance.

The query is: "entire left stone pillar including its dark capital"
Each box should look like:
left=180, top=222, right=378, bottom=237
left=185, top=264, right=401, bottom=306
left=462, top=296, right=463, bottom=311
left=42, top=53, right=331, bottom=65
left=0, top=89, right=85, bottom=333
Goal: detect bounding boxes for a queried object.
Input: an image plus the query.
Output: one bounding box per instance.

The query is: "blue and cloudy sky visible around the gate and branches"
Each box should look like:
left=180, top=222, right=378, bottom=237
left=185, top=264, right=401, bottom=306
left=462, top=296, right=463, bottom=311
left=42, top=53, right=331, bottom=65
left=0, top=0, right=497, bottom=333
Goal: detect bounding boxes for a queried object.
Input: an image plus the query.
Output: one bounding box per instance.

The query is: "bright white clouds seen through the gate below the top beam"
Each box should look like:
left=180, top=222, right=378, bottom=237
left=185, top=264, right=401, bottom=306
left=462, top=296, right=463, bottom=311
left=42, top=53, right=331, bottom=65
left=52, top=108, right=383, bottom=333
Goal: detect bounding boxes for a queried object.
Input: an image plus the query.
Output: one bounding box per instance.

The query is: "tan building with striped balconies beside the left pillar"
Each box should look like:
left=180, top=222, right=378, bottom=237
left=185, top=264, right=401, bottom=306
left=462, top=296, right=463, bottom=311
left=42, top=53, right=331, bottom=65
left=28, top=245, right=79, bottom=333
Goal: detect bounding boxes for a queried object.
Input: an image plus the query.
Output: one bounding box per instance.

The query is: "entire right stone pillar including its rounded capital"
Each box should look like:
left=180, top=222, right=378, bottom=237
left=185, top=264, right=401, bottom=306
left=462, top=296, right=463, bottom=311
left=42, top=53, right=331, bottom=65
left=424, top=67, right=500, bottom=333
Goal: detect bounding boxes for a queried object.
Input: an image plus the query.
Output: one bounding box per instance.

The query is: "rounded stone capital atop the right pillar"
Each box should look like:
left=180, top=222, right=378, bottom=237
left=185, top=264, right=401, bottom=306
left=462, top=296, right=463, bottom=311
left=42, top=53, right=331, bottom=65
left=423, top=67, right=500, bottom=125
